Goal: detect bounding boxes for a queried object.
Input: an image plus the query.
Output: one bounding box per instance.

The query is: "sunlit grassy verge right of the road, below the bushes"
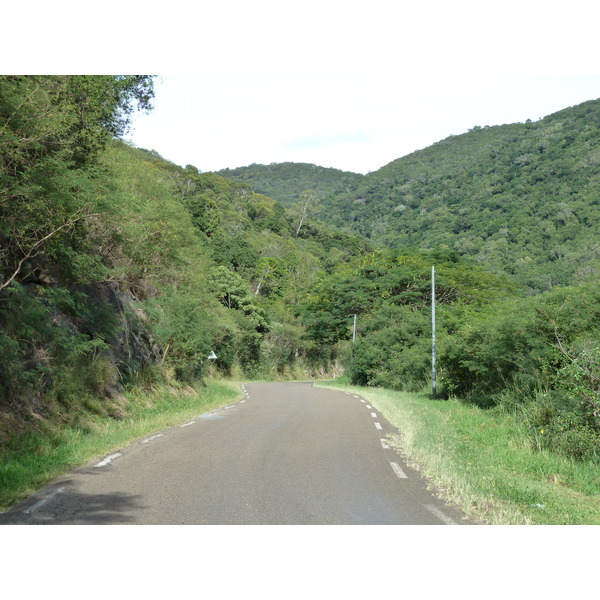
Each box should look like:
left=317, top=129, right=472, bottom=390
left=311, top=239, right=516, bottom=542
left=320, top=382, right=600, bottom=525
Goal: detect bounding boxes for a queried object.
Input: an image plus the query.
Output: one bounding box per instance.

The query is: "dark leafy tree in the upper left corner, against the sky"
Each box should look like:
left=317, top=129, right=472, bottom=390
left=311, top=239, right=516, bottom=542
left=0, top=75, right=153, bottom=289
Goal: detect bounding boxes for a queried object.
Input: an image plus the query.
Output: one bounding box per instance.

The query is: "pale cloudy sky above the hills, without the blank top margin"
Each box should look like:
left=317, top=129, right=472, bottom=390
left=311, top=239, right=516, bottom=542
left=127, top=73, right=600, bottom=173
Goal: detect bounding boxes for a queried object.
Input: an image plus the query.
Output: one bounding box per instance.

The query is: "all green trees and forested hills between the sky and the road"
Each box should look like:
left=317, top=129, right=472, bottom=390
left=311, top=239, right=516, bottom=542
left=0, top=76, right=600, bottom=474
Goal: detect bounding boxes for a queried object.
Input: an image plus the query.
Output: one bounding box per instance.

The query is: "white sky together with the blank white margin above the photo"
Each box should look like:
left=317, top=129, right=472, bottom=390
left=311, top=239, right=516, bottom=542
left=5, top=0, right=600, bottom=173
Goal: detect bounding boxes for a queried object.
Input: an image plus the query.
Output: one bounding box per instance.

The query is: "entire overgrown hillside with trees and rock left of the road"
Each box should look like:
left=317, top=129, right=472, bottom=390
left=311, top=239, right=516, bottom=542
left=0, top=76, right=369, bottom=446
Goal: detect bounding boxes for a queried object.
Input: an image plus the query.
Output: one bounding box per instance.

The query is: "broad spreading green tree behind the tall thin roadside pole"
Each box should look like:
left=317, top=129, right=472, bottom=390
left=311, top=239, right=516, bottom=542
left=300, top=250, right=508, bottom=389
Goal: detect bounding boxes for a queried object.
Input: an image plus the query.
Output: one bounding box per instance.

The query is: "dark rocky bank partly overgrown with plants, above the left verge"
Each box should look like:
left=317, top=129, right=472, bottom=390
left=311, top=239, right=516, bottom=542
left=0, top=271, right=164, bottom=436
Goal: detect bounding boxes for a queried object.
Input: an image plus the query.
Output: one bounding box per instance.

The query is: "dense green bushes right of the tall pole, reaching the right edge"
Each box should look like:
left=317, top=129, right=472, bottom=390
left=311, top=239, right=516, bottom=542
left=440, top=286, right=600, bottom=459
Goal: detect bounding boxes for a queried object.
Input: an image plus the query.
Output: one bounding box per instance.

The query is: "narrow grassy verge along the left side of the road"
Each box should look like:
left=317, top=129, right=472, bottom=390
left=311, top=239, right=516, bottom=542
left=0, top=381, right=240, bottom=510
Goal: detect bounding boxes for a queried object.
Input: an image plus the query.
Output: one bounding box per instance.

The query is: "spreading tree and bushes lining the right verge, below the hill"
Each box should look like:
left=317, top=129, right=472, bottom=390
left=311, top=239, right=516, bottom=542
left=303, top=250, right=600, bottom=460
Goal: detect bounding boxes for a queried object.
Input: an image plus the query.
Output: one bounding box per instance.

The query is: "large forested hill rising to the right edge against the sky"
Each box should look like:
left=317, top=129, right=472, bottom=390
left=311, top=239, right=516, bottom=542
left=320, top=100, right=600, bottom=291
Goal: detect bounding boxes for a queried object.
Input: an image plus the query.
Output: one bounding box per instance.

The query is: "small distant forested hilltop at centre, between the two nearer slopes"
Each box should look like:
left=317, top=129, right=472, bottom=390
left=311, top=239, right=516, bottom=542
left=218, top=162, right=363, bottom=207
